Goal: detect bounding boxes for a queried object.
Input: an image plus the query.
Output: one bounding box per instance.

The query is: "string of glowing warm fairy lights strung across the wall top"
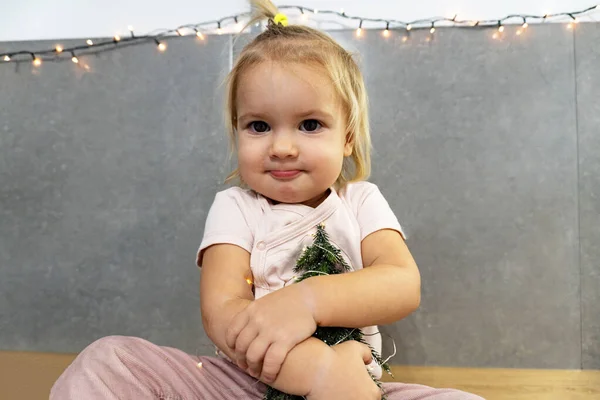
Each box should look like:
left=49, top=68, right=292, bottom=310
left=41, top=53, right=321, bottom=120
left=0, top=5, right=600, bottom=66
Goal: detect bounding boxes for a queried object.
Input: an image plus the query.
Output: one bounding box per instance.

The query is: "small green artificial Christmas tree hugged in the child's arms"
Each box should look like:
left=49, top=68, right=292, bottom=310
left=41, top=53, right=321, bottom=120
left=264, top=224, right=391, bottom=400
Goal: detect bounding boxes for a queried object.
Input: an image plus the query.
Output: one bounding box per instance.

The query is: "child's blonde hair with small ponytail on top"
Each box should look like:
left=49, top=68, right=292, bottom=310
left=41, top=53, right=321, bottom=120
left=225, top=0, right=371, bottom=189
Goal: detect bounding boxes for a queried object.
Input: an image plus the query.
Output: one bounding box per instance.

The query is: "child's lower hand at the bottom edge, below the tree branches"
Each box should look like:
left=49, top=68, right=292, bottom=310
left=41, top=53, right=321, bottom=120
left=306, top=340, right=381, bottom=400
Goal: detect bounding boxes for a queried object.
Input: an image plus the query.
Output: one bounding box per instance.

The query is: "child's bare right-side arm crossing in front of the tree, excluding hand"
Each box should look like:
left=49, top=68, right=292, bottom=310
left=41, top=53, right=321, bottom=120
left=300, top=229, right=421, bottom=328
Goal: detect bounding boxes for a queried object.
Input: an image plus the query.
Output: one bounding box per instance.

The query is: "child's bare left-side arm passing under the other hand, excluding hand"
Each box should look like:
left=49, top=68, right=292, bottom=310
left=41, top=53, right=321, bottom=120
left=200, top=244, right=333, bottom=396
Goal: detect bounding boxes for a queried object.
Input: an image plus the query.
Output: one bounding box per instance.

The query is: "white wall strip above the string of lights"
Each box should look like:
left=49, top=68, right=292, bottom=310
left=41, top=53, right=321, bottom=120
left=0, top=0, right=600, bottom=41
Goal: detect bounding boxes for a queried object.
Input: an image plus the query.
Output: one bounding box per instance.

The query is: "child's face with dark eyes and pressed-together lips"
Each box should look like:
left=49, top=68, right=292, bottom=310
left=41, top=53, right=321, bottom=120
left=236, top=62, right=352, bottom=206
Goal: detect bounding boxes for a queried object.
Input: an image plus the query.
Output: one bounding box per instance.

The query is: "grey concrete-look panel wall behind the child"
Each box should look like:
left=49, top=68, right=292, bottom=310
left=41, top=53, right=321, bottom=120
left=0, top=24, right=600, bottom=368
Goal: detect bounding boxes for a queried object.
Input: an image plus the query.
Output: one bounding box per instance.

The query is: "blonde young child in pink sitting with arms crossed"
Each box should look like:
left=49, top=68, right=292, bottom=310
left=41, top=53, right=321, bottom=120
left=50, top=0, right=480, bottom=400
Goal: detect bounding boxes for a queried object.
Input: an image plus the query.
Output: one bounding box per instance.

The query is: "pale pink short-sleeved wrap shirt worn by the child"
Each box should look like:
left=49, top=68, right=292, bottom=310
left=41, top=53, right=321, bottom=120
left=197, top=182, right=405, bottom=377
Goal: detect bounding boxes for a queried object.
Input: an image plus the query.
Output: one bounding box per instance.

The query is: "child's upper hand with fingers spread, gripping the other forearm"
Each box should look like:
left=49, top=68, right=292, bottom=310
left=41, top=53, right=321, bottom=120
left=226, top=283, right=317, bottom=384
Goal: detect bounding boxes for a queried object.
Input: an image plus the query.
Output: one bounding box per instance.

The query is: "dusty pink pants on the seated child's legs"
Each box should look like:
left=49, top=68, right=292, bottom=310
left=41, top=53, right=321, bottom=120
left=50, top=336, right=482, bottom=400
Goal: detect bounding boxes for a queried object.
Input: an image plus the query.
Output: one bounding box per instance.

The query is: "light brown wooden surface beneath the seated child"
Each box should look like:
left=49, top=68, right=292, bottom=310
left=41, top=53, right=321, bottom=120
left=0, top=352, right=600, bottom=400
